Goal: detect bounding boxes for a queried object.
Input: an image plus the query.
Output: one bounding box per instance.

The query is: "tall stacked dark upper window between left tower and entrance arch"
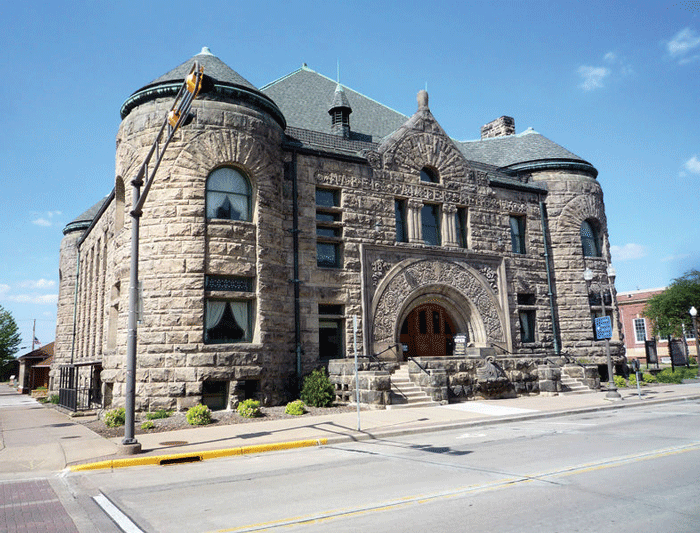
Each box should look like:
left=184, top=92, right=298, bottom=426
left=316, top=189, right=343, bottom=268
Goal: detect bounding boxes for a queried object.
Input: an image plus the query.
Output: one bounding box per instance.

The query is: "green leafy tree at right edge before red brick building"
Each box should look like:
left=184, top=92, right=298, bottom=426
left=642, top=269, right=700, bottom=338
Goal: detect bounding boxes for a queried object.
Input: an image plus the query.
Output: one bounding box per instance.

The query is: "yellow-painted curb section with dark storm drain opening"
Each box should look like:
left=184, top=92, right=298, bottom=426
left=68, top=439, right=328, bottom=472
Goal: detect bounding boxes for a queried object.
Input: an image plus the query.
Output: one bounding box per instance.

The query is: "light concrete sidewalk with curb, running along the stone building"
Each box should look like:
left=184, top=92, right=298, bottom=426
left=0, top=383, right=700, bottom=478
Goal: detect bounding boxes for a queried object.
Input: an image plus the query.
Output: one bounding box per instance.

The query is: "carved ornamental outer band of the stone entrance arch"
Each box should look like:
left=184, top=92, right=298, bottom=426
left=372, top=259, right=505, bottom=342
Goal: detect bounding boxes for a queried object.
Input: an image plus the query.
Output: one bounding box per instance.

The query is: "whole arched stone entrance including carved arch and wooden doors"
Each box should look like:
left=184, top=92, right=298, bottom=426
left=369, top=259, right=506, bottom=360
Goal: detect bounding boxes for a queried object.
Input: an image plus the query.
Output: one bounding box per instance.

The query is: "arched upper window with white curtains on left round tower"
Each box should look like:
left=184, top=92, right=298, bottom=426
left=207, top=167, right=251, bottom=220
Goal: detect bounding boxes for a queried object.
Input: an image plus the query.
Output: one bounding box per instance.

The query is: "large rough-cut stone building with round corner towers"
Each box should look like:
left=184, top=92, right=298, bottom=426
left=52, top=48, right=624, bottom=409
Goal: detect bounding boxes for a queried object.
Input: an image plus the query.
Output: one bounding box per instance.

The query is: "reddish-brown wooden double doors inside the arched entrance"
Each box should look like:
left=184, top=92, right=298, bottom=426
left=399, top=303, right=455, bottom=359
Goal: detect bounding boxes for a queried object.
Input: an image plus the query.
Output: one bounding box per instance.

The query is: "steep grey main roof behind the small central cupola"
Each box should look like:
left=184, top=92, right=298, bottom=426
left=260, top=65, right=408, bottom=142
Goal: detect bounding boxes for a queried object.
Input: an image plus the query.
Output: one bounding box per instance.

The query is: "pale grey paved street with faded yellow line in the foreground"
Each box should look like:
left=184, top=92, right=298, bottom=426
left=62, top=400, right=700, bottom=533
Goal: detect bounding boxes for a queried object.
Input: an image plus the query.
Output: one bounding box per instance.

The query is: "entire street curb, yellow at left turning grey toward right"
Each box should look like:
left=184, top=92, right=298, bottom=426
left=68, top=394, right=700, bottom=472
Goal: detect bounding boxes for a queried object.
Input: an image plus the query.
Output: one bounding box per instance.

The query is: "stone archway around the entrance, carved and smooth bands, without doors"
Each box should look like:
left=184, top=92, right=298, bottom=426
left=370, top=259, right=506, bottom=353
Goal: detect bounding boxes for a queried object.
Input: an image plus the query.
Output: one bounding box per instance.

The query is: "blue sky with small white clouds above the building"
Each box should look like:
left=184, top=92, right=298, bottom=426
left=0, top=0, right=700, bottom=345
